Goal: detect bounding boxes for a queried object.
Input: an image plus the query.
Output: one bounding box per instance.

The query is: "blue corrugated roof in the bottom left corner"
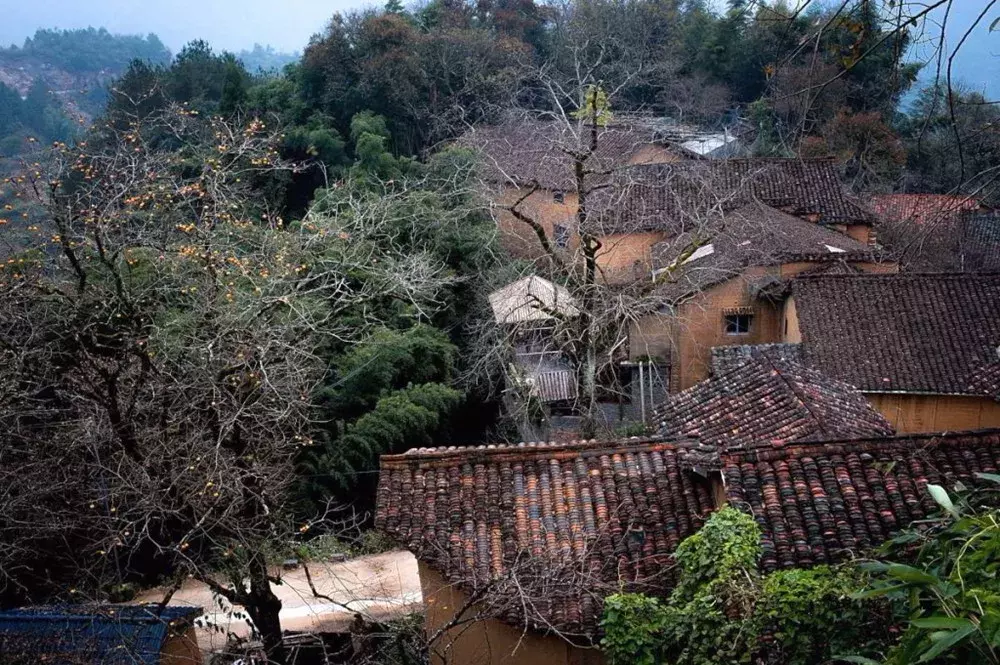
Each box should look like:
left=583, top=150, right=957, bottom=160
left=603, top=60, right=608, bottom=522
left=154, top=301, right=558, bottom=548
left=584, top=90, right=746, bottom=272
left=0, top=605, right=202, bottom=665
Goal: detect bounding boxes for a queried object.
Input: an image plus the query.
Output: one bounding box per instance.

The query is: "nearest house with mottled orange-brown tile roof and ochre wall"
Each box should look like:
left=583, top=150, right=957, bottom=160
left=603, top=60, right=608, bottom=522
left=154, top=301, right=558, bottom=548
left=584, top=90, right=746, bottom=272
left=376, top=428, right=1000, bottom=665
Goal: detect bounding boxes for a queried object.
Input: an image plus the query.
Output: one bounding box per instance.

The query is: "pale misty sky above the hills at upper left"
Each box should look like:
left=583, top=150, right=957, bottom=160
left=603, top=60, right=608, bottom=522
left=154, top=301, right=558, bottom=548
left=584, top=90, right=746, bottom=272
left=0, top=0, right=383, bottom=53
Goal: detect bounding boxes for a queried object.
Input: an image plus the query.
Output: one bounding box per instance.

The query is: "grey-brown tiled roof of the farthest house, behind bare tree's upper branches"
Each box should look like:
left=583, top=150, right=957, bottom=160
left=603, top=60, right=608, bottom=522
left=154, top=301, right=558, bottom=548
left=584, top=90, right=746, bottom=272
left=459, top=118, right=690, bottom=192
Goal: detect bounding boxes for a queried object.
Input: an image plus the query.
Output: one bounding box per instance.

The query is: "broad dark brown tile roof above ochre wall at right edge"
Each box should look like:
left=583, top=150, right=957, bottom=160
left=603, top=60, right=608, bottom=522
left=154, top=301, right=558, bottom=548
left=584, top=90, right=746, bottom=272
left=792, top=273, right=1000, bottom=394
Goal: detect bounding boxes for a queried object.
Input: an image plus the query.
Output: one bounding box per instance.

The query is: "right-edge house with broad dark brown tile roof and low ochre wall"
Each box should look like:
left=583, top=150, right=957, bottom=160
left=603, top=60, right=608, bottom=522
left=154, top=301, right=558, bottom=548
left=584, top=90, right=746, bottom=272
left=781, top=274, right=1000, bottom=432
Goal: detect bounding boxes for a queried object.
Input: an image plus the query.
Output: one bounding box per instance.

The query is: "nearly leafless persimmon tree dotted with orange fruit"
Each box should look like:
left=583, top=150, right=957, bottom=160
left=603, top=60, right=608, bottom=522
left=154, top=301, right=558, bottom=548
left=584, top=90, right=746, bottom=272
left=0, top=106, right=449, bottom=663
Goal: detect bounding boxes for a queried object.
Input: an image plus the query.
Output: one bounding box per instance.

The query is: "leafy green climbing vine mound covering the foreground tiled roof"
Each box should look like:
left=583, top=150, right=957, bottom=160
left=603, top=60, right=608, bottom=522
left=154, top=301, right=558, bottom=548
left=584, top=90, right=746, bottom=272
left=601, top=508, right=885, bottom=665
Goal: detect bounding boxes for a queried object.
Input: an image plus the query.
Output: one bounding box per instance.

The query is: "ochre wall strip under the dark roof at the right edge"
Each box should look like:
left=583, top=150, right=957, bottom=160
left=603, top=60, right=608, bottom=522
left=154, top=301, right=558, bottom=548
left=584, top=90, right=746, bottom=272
left=865, top=393, right=1000, bottom=434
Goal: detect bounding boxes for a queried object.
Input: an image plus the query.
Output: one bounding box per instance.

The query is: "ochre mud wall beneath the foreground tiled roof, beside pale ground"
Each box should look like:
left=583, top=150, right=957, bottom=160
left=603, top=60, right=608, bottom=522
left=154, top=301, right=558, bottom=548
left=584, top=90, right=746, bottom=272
left=418, top=562, right=604, bottom=665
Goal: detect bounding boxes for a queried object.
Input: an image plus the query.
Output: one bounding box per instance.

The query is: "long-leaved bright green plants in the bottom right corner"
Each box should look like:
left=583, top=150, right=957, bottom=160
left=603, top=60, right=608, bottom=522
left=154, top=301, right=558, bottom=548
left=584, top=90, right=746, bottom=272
left=858, top=474, right=1000, bottom=665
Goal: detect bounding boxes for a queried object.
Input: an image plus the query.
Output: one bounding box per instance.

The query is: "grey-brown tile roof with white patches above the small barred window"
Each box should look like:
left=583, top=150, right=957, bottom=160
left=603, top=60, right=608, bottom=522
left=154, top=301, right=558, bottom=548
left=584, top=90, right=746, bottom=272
left=651, top=202, right=879, bottom=301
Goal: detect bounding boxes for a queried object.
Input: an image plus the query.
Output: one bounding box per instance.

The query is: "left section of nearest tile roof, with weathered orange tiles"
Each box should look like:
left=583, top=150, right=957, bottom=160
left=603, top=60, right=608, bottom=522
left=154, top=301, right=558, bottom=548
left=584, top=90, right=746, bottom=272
left=375, top=437, right=713, bottom=637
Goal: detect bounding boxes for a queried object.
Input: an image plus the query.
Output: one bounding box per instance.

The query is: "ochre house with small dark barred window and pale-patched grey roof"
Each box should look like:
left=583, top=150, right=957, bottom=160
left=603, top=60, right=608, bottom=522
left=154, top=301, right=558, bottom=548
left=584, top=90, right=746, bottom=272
left=629, top=202, right=898, bottom=392
